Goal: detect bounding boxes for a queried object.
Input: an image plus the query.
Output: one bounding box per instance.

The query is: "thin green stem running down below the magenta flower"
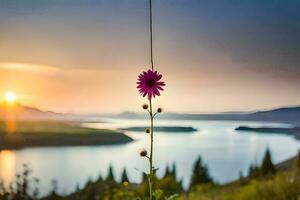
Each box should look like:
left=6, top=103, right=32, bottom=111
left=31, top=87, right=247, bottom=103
left=149, top=98, right=154, bottom=200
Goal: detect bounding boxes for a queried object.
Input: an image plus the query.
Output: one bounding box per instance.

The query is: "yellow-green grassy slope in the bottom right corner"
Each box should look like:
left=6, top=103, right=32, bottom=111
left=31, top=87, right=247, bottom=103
left=179, top=156, right=300, bottom=200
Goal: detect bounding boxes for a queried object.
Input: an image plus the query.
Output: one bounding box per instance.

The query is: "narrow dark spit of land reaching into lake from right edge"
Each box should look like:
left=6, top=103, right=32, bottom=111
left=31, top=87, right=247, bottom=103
left=235, top=126, right=300, bottom=140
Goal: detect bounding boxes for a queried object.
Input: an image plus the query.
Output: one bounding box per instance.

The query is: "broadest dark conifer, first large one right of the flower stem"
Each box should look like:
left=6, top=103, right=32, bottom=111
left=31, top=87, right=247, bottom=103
left=190, top=156, right=213, bottom=188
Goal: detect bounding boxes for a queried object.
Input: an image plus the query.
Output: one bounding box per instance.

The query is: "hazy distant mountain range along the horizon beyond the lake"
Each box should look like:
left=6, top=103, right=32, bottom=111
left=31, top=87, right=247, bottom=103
left=0, top=104, right=300, bottom=125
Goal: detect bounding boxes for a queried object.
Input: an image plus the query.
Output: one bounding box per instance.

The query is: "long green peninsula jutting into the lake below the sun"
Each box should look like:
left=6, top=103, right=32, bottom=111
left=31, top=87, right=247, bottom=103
left=0, top=121, right=132, bottom=150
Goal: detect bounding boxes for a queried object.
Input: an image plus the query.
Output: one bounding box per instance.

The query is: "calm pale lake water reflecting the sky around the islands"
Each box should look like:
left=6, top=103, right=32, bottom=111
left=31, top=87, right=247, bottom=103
left=0, top=119, right=300, bottom=194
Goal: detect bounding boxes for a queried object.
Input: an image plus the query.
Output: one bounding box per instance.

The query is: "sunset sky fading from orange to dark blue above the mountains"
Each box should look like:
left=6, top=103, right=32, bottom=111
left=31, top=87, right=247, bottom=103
left=0, top=0, right=300, bottom=113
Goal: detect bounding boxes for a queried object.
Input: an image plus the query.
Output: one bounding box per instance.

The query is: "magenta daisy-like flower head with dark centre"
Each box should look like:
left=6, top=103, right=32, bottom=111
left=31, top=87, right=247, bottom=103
left=137, top=69, right=166, bottom=99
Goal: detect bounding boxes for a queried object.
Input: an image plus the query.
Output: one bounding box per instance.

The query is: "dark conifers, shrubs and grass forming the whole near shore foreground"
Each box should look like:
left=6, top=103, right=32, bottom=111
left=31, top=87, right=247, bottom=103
left=0, top=150, right=300, bottom=200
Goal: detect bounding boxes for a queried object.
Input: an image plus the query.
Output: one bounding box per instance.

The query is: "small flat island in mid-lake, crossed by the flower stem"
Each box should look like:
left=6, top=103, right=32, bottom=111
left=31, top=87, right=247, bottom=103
left=120, top=126, right=197, bottom=133
